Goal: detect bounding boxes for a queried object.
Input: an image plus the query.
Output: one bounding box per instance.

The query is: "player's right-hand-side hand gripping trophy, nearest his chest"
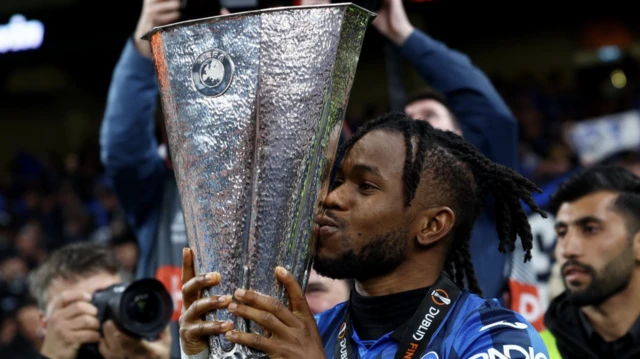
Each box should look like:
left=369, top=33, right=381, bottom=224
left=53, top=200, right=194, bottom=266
left=227, top=267, right=325, bottom=359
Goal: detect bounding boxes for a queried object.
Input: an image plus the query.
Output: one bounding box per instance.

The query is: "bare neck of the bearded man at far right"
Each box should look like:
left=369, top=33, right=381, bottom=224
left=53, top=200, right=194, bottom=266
left=582, top=273, right=640, bottom=341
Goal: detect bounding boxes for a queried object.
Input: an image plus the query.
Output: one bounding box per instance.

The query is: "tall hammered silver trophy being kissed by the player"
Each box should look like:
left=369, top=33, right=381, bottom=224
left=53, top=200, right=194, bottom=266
left=146, top=4, right=374, bottom=358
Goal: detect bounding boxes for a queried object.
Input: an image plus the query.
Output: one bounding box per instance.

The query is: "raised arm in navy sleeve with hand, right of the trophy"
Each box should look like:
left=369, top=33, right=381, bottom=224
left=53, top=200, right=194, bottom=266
left=374, top=0, right=518, bottom=168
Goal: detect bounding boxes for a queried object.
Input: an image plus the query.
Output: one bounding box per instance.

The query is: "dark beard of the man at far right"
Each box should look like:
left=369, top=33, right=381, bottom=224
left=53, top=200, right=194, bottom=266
left=562, top=242, right=636, bottom=307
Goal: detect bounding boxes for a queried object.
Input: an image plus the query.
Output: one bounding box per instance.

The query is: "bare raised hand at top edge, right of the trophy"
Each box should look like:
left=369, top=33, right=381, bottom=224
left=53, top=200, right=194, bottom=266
left=373, top=0, right=413, bottom=46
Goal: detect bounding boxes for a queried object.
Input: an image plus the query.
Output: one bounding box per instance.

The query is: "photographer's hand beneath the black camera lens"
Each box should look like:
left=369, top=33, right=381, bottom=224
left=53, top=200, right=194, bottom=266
left=98, top=320, right=171, bottom=359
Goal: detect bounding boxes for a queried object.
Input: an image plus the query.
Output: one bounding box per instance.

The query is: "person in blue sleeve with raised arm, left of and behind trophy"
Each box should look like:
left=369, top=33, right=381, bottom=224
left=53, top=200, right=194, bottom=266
left=100, top=0, right=187, bottom=358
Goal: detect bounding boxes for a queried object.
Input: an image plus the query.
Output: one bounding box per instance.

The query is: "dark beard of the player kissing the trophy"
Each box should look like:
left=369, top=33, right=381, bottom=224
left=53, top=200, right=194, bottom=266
left=313, top=226, right=409, bottom=282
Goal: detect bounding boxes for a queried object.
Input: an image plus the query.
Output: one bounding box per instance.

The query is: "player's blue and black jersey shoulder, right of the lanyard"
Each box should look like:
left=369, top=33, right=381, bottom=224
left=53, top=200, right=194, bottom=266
left=453, top=294, right=549, bottom=359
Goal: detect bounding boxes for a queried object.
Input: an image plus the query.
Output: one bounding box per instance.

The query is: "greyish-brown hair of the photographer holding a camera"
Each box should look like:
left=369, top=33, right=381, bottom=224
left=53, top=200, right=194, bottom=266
left=31, top=243, right=119, bottom=311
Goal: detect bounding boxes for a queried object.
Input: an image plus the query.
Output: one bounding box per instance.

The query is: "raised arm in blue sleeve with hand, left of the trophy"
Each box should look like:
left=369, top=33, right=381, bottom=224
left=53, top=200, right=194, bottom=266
left=100, top=0, right=180, bottom=226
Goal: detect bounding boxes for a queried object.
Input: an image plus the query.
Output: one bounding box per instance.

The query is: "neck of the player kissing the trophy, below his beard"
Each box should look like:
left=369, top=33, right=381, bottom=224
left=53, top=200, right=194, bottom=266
left=356, top=257, right=442, bottom=297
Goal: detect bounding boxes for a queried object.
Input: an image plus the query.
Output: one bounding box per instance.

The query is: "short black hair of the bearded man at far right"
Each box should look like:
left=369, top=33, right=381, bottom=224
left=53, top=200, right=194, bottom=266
left=549, top=166, right=640, bottom=234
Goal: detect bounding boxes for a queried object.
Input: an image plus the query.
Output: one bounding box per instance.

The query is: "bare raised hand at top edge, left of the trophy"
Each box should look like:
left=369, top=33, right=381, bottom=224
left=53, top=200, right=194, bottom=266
left=133, top=0, right=181, bottom=59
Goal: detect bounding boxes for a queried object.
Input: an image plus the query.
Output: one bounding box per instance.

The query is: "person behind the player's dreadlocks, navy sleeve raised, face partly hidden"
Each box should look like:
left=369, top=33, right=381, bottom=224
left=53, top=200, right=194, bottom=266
left=373, top=0, right=543, bottom=329
